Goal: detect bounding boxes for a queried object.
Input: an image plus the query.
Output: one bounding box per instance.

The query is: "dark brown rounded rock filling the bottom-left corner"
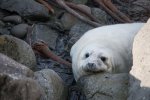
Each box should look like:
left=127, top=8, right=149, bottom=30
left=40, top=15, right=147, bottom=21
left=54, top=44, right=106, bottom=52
left=0, top=73, right=46, bottom=100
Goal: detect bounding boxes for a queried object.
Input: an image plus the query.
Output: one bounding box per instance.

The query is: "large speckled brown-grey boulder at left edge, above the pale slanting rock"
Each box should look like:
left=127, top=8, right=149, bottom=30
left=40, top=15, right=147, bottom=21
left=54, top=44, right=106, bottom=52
left=0, top=35, right=36, bottom=70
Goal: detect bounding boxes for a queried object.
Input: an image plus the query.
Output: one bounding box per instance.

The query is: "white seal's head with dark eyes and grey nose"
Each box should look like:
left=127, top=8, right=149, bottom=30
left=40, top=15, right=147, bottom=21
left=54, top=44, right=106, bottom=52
left=76, top=44, right=113, bottom=79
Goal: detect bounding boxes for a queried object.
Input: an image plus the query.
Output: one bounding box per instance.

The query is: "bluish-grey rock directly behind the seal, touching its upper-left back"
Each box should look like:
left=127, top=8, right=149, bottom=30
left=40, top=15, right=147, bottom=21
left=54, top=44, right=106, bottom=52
left=68, top=21, right=94, bottom=48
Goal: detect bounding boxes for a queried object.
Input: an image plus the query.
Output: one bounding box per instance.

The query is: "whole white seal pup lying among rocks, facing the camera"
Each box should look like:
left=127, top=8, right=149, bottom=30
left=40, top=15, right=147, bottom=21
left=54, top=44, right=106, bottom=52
left=70, top=23, right=144, bottom=80
